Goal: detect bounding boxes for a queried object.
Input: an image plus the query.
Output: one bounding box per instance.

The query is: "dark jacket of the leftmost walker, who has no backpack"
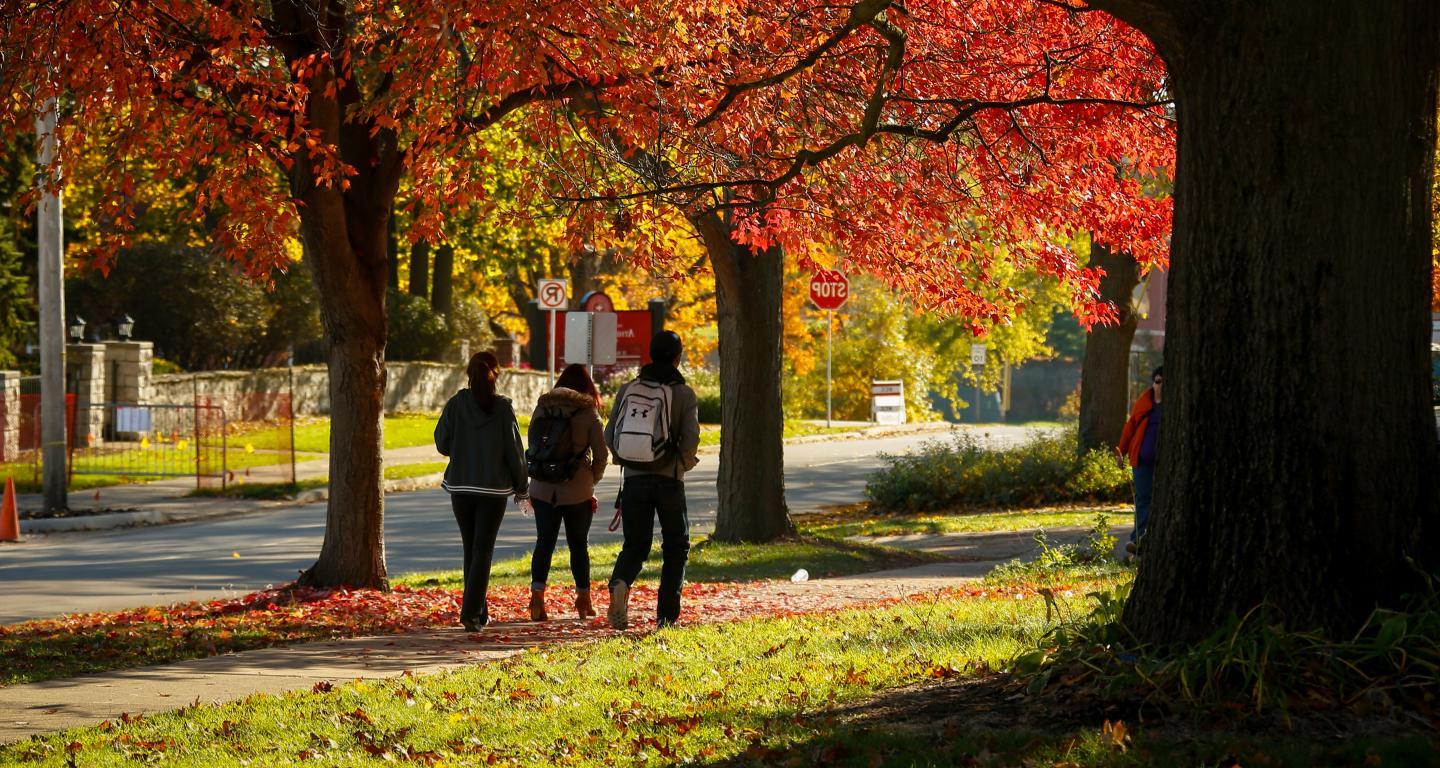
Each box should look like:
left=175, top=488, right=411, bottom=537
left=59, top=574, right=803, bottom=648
left=435, top=389, right=530, bottom=496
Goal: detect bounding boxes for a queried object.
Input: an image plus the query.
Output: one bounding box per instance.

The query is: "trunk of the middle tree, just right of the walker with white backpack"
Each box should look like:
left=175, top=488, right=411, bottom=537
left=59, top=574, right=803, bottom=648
left=696, top=215, right=795, bottom=542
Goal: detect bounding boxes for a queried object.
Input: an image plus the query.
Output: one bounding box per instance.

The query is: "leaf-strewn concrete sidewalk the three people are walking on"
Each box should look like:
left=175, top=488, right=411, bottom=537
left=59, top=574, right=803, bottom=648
left=0, top=527, right=1048, bottom=744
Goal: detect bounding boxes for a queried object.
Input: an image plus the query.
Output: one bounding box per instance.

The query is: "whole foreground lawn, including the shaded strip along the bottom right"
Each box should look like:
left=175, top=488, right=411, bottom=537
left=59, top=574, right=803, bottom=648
left=0, top=585, right=1422, bottom=768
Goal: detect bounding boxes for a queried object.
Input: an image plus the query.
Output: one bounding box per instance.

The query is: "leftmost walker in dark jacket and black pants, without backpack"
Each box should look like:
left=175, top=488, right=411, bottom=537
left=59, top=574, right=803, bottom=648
left=435, top=352, right=530, bottom=633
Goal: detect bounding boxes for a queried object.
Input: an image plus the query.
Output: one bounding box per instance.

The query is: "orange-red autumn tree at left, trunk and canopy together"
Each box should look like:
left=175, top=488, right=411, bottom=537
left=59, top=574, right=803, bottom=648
left=0, top=0, right=685, bottom=586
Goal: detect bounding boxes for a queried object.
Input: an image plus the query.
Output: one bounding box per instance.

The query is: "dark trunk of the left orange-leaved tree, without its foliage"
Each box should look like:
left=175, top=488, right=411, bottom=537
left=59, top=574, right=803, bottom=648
left=274, top=0, right=403, bottom=588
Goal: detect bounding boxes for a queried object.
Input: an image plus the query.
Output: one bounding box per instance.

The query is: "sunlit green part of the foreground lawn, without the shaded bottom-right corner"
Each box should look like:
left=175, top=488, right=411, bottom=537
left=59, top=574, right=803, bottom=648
left=0, top=598, right=1045, bottom=767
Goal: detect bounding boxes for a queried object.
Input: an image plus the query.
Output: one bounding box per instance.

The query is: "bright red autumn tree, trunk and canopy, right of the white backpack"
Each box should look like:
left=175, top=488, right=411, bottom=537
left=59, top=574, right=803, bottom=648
left=541, top=0, right=1171, bottom=540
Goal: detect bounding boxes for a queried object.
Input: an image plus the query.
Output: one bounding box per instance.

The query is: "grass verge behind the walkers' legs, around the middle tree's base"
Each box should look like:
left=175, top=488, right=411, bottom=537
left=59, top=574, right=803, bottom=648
left=393, top=537, right=935, bottom=589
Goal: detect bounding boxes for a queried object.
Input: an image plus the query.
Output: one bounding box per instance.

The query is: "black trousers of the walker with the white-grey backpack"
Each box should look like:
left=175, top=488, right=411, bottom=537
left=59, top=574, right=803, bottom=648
left=611, top=474, right=690, bottom=625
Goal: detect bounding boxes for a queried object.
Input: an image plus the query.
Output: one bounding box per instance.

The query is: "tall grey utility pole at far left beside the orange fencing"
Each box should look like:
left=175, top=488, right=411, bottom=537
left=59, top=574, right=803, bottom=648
left=35, top=97, right=69, bottom=512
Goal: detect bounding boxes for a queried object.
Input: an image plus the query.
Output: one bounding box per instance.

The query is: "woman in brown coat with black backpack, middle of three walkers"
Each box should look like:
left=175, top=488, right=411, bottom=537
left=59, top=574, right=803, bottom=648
left=526, top=363, right=609, bottom=621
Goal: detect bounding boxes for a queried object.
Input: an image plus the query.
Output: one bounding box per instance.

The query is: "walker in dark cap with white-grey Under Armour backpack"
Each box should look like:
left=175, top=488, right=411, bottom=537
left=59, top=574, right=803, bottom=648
left=605, top=330, right=700, bottom=630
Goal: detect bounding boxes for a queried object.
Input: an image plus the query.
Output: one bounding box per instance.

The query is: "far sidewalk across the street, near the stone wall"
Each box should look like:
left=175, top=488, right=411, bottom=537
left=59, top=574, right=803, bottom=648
left=17, top=422, right=956, bottom=535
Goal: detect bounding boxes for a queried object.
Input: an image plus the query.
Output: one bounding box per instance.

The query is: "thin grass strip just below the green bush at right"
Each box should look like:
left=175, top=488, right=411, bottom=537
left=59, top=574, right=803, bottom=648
left=796, top=507, right=1130, bottom=537
